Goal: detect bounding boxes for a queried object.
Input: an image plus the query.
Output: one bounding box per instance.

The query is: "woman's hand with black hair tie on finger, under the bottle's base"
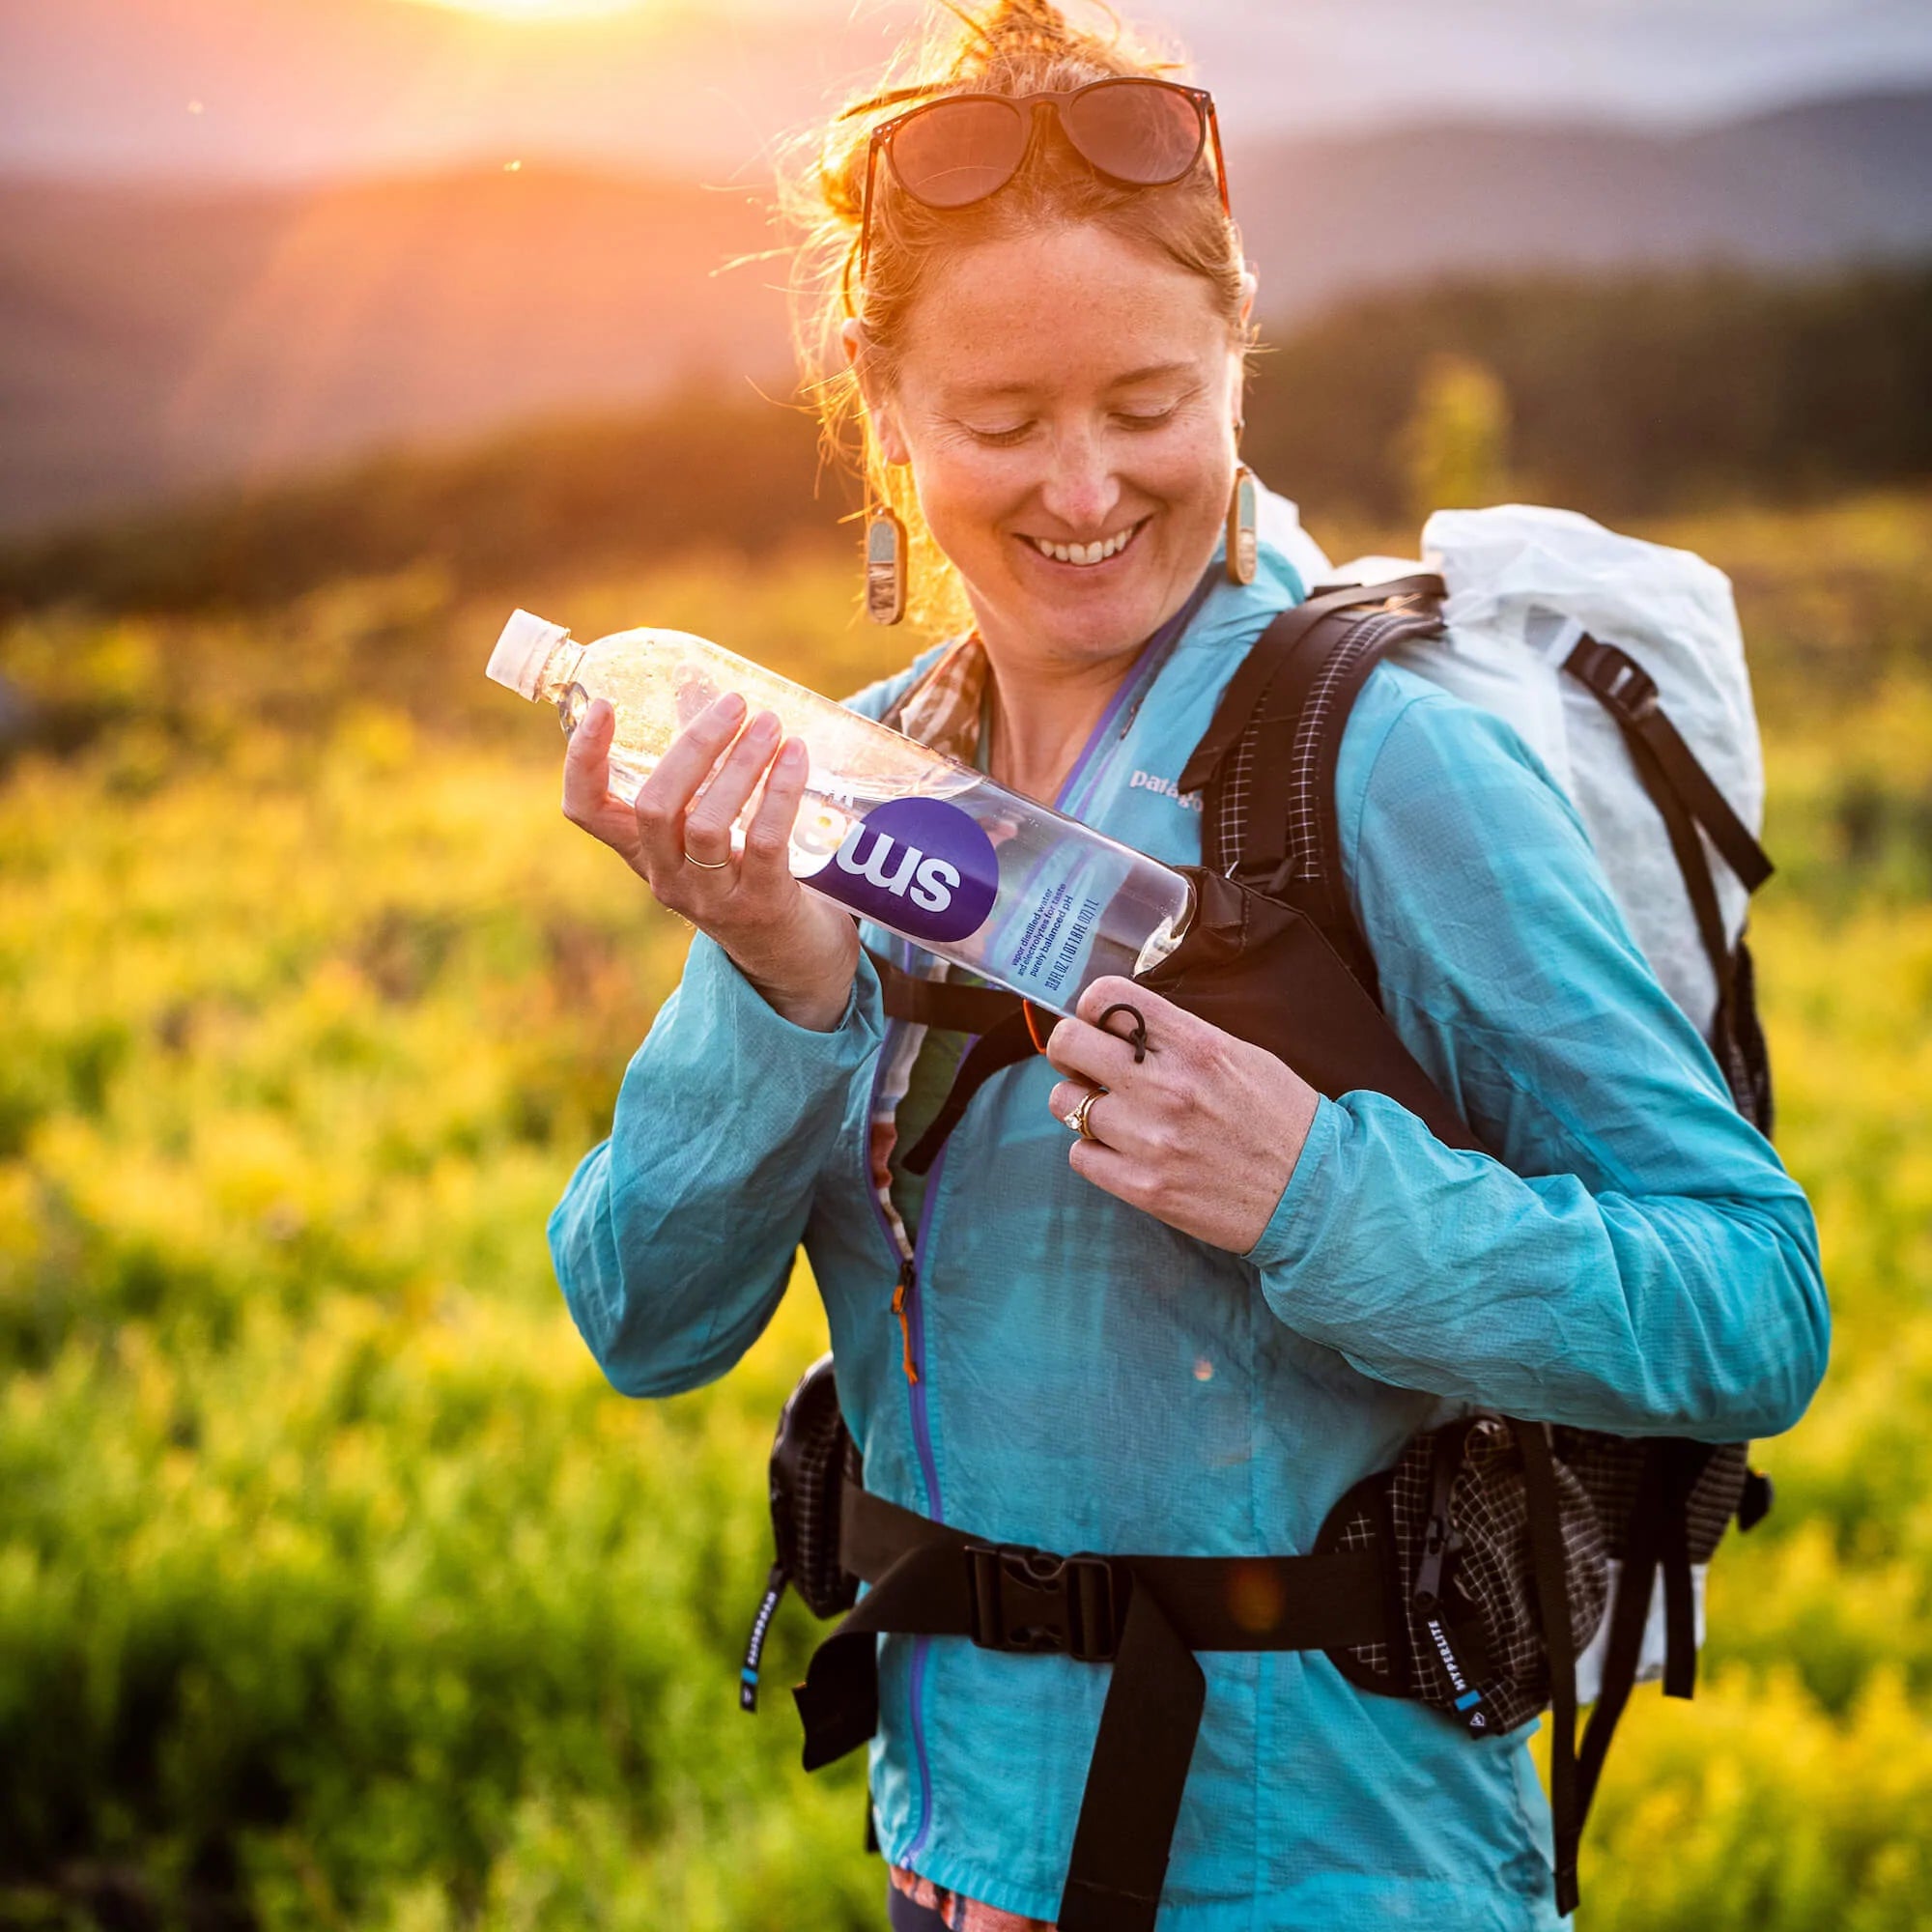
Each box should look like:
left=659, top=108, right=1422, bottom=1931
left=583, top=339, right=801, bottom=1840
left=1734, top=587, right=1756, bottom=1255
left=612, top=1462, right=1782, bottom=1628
left=1047, top=980, right=1316, bottom=1254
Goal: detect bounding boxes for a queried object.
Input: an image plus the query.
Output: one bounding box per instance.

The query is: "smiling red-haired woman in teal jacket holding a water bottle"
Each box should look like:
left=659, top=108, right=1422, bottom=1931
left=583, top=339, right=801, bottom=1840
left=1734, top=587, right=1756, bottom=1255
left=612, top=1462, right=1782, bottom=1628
left=551, top=0, right=1826, bottom=1932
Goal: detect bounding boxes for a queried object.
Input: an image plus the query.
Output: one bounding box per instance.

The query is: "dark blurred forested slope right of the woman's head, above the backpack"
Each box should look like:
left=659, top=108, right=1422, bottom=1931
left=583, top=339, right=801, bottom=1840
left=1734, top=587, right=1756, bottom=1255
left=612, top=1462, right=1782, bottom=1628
left=1244, top=267, right=1932, bottom=520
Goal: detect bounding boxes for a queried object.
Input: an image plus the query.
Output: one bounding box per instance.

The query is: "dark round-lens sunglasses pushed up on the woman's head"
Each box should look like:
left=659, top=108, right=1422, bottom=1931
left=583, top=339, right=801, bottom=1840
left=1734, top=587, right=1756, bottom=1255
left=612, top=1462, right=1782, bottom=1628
left=858, top=75, right=1231, bottom=276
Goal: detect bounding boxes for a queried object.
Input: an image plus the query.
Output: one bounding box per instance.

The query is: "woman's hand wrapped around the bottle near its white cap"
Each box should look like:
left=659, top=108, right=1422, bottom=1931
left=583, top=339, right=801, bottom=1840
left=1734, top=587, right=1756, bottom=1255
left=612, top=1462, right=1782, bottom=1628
left=564, top=692, right=858, bottom=1034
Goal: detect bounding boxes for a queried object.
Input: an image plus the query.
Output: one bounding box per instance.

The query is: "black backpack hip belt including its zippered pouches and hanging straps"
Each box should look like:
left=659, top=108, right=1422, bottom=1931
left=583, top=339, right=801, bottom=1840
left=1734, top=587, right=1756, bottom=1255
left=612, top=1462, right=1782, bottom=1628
left=761, top=1356, right=1770, bottom=1932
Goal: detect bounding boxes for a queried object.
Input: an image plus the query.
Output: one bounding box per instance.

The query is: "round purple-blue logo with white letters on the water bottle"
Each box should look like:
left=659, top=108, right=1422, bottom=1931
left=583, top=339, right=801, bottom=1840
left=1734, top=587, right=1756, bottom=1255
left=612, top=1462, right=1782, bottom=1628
left=811, top=798, right=999, bottom=945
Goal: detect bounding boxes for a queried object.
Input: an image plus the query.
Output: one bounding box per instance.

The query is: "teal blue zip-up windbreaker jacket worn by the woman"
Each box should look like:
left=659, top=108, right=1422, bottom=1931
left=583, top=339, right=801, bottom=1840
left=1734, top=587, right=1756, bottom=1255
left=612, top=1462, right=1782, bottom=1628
left=551, top=522, right=1828, bottom=1932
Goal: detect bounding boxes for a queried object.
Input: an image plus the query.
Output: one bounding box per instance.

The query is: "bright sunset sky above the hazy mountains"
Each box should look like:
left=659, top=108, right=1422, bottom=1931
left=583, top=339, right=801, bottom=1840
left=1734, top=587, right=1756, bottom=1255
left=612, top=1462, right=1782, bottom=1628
left=0, top=0, right=1932, bottom=182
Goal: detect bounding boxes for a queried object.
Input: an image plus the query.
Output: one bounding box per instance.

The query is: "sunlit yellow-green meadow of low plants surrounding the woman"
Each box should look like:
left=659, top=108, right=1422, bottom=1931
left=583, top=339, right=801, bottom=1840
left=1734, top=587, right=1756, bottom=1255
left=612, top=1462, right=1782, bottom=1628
left=0, top=497, right=1932, bottom=1932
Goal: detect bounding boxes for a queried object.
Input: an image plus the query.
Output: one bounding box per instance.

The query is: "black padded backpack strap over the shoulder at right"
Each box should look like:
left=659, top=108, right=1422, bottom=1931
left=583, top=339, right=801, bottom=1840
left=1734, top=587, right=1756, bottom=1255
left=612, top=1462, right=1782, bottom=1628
left=1180, top=574, right=1445, bottom=993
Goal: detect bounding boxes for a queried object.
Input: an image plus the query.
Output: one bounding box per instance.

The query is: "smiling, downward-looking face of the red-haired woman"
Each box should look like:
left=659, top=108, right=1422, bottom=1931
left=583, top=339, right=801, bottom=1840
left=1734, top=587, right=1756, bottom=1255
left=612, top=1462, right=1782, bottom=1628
left=873, top=224, right=1240, bottom=668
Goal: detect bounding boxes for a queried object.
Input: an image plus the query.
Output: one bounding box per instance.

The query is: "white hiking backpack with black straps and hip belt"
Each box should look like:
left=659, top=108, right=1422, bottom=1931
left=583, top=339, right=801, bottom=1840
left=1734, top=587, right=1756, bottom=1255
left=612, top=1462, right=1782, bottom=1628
left=748, top=506, right=1772, bottom=1932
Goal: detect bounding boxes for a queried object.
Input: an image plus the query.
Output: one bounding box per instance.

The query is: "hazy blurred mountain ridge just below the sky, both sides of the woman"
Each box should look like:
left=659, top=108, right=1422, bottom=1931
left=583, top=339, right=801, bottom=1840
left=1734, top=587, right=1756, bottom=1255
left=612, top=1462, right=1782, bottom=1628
left=0, top=89, right=1932, bottom=529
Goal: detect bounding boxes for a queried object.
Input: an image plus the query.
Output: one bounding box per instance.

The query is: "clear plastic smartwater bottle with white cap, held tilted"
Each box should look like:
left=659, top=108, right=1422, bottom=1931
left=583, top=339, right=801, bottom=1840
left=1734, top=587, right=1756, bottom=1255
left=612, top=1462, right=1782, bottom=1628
left=489, top=611, right=1192, bottom=1012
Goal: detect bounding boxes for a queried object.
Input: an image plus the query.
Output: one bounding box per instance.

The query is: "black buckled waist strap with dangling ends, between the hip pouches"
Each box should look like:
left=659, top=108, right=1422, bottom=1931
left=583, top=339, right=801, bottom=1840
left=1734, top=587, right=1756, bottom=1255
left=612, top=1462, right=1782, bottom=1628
left=796, top=1486, right=1387, bottom=1932
